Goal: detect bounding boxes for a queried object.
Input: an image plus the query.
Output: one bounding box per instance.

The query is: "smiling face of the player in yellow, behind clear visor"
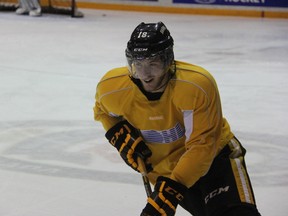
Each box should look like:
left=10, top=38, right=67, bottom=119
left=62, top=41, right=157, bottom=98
left=133, top=57, right=169, bottom=92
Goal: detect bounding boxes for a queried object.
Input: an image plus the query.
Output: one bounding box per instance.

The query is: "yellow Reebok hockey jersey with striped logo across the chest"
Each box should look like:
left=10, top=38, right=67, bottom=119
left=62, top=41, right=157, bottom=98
left=94, top=61, right=233, bottom=187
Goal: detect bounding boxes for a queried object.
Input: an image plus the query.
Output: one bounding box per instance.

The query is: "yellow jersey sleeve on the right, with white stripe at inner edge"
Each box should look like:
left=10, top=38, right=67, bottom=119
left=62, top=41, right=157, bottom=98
left=170, top=66, right=223, bottom=187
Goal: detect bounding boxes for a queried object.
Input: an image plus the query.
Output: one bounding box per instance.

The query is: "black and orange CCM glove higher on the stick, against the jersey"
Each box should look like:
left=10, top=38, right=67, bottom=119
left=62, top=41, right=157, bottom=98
left=105, top=120, right=152, bottom=172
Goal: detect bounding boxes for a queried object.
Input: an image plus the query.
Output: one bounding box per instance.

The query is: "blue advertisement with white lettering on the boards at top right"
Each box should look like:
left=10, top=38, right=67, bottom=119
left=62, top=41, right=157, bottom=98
left=173, top=0, right=288, bottom=7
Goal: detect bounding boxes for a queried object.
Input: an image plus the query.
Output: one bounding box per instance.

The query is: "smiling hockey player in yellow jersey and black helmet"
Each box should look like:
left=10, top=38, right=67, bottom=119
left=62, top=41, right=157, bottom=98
left=94, top=22, right=260, bottom=216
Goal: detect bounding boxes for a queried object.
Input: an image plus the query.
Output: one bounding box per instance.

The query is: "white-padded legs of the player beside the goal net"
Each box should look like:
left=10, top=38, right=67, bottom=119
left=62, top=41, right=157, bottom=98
left=16, top=0, right=42, bottom=17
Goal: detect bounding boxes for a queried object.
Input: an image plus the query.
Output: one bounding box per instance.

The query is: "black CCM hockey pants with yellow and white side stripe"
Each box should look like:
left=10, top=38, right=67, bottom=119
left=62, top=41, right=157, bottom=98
left=180, top=138, right=260, bottom=216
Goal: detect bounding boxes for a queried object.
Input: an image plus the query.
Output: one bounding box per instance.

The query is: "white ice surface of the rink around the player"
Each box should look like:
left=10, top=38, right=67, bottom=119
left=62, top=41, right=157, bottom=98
left=0, top=10, right=288, bottom=216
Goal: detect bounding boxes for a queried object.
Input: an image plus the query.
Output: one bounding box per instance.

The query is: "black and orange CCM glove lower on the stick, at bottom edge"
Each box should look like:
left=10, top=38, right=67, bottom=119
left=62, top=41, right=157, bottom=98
left=140, top=176, right=187, bottom=216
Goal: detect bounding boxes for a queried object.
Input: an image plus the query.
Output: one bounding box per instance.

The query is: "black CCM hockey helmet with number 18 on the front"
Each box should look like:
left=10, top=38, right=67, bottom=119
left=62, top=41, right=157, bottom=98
left=126, top=22, right=174, bottom=74
